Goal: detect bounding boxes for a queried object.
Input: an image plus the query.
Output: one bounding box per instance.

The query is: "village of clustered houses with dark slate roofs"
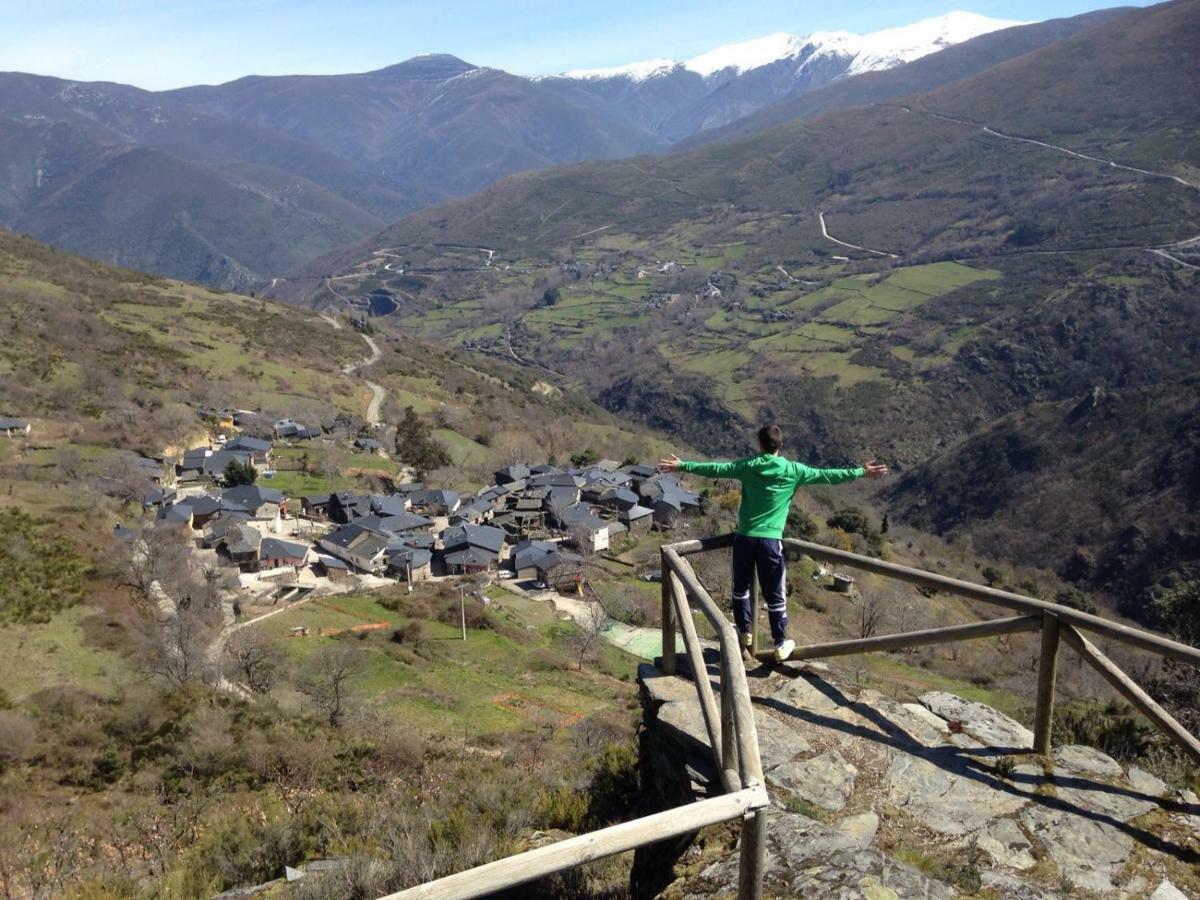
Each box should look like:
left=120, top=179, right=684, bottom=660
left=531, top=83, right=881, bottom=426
left=125, top=422, right=701, bottom=600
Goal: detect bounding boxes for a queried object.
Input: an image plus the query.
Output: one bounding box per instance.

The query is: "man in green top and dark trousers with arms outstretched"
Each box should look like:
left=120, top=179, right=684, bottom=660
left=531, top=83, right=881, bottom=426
left=659, top=425, right=888, bottom=661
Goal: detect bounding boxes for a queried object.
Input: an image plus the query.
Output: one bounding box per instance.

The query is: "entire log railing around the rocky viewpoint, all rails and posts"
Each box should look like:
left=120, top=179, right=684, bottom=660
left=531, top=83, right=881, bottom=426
left=385, top=534, right=1200, bottom=900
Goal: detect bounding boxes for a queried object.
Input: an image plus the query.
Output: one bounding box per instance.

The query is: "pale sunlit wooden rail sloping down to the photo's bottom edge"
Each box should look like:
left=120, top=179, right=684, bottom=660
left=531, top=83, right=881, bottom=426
left=383, top=786, right=770, bottom=900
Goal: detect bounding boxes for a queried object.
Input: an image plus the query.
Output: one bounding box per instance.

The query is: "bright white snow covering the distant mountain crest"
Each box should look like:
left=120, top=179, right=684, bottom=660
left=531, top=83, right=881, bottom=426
left=552, top=11, right=1026, bottom=82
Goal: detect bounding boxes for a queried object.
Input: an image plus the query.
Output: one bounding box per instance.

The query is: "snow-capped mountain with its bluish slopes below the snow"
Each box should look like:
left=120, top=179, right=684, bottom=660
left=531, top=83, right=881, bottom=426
left=538, top=12, right=1024, bottom=142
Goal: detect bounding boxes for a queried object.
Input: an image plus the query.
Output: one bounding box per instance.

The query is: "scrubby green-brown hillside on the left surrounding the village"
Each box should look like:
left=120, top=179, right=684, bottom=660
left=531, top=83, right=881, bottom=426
left=0, top=232, right=681, bottom=898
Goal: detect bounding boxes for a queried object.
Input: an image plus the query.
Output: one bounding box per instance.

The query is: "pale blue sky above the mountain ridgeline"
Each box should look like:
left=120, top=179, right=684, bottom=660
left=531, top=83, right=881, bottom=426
left=0, top=0, right=1145, bottom=89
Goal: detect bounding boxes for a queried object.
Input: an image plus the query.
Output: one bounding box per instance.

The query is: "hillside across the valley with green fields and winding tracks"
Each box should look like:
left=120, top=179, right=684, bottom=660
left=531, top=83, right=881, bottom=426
left=288, top=2, right=1200, bottom=624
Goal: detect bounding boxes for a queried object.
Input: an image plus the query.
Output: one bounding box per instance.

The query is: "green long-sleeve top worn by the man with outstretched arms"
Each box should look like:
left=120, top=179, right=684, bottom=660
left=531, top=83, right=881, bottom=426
left=679, top=454, right=866, bottom=538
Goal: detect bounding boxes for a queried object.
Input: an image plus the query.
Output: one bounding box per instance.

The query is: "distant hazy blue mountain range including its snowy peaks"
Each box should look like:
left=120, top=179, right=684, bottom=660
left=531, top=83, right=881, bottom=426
left=0, top=13, right=1085, bottom=290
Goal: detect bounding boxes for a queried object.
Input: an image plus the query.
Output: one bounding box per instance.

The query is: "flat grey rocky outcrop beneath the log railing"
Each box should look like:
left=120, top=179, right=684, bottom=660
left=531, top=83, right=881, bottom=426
left=638, top=660, right=1200, bottom=900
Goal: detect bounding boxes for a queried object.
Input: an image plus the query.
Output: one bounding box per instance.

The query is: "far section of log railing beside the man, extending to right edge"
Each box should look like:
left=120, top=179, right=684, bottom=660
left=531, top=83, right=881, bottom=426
left=662, top=534, right=1200, bottom=764
